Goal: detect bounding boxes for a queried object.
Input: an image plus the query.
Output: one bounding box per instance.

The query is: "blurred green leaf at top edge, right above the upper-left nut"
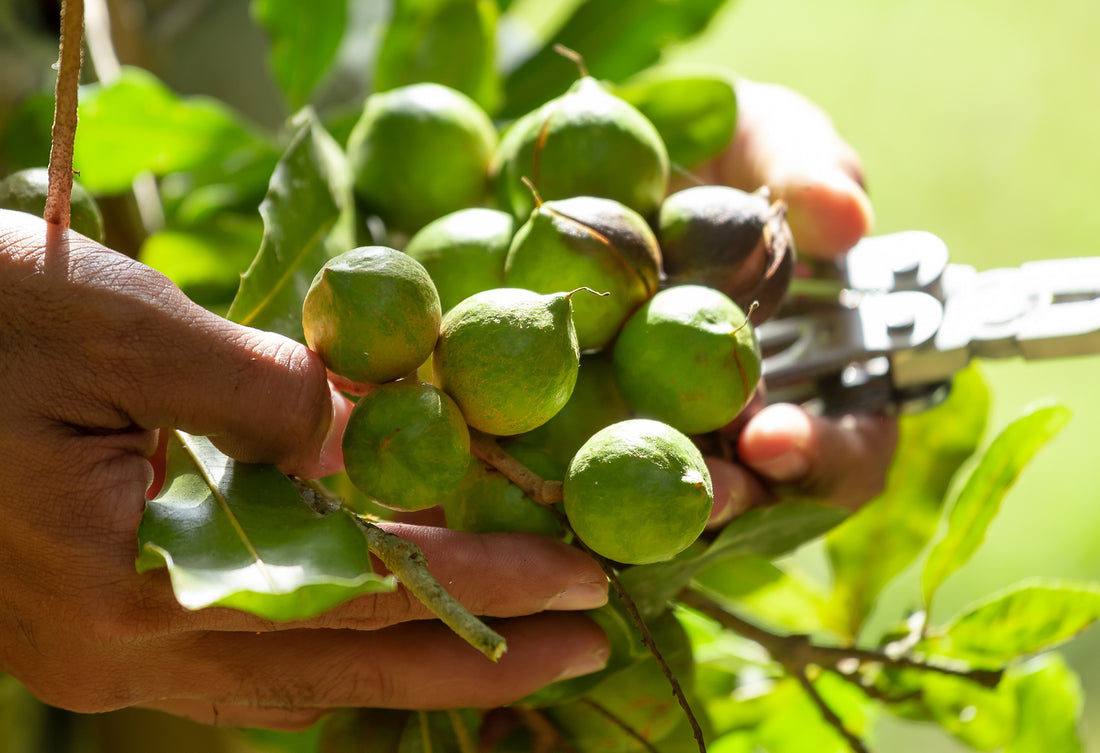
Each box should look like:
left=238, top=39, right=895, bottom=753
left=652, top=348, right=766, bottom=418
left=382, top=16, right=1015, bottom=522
left=374, top=0, right=501, bottom=113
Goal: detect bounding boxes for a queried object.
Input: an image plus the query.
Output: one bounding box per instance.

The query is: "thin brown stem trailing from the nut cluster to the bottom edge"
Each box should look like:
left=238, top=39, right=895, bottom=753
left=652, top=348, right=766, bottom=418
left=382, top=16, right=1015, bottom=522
left=470, top=432, right=706, bottom=753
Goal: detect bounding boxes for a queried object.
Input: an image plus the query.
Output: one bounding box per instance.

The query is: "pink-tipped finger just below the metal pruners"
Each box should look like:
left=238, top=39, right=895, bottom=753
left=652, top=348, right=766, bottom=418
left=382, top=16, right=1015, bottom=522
left=737, top=403, right=898, bottom=510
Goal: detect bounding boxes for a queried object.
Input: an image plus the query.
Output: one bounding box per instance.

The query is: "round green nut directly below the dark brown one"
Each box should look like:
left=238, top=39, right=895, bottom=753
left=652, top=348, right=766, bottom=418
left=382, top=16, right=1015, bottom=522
left=613, top=285, right=761, bottom=434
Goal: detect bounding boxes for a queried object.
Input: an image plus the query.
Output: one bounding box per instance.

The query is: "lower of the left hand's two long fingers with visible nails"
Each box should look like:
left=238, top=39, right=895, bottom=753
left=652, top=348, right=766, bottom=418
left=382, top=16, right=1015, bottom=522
left=162, top=612, right=609, bottom=709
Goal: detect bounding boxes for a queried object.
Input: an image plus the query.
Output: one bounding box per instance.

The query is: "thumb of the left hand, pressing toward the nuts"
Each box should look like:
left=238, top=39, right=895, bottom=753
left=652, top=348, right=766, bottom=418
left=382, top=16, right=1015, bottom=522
left=2, top=206, right=348, bottom=475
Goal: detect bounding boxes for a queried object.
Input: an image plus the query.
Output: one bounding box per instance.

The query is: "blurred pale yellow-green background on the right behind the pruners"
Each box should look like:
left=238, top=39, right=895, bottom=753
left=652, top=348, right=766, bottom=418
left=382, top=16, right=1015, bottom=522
left=675, top=0, right=1100, bottom=752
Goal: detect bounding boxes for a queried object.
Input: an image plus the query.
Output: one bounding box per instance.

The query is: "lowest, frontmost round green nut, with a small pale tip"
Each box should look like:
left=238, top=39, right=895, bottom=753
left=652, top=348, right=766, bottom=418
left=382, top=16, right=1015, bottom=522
left=562, top=419, right=714, bottom=565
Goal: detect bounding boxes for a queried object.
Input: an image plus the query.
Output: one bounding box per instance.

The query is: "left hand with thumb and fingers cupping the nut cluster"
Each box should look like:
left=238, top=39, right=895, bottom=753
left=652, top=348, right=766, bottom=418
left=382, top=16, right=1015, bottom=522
left=0, top=211, right=607, bottom=729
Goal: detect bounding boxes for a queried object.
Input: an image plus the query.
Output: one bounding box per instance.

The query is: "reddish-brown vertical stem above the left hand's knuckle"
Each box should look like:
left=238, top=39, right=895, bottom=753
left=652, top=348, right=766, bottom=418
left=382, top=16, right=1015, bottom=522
left=43, top=0, right=84, bottom=230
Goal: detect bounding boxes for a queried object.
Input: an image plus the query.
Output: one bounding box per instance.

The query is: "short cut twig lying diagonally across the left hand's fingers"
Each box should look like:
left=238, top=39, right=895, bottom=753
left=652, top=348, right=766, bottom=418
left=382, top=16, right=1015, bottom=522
left=294, top=479, right=507, bottom=662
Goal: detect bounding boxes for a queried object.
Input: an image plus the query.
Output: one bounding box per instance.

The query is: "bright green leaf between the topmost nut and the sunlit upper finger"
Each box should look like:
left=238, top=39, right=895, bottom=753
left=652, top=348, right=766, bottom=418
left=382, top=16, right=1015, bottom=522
left=615, top=68, right=737, bottom=168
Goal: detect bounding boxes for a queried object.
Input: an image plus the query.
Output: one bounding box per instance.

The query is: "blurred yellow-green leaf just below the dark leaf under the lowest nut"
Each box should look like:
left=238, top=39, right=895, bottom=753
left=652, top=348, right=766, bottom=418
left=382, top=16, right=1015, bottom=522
left=692, top=556, right=835, bottom=633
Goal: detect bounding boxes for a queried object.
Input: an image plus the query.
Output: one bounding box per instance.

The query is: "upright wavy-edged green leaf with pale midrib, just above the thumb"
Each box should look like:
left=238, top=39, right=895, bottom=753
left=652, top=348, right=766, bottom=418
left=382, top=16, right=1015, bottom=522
left=229, top=110, right=352, bottom=341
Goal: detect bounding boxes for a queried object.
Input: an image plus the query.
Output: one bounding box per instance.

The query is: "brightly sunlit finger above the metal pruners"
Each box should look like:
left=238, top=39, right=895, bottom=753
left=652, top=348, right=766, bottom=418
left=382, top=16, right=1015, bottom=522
left=701, top=79, right=875, bottom=258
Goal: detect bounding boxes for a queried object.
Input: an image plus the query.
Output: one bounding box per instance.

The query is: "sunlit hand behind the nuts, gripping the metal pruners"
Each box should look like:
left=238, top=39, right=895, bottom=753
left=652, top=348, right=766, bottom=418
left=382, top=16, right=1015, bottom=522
left=694, top=79, right=898, bottom=518
